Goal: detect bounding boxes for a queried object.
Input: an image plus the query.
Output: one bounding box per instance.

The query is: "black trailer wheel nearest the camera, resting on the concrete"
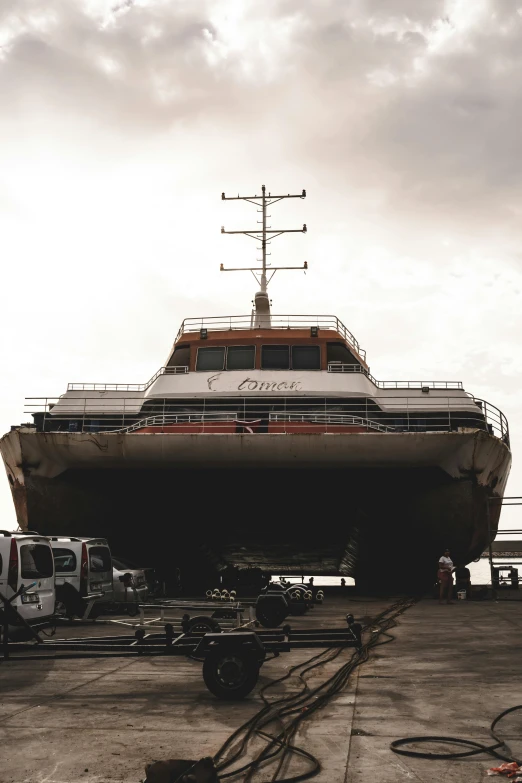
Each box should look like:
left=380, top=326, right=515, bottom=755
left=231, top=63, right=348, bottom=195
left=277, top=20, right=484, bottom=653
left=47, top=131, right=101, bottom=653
left=203, top=653, right=259, bottom=701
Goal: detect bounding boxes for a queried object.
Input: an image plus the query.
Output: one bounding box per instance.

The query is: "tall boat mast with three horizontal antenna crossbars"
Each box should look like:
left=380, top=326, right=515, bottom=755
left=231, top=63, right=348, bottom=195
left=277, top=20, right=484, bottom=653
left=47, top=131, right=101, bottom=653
left=220, top=185, right=308, bottom=327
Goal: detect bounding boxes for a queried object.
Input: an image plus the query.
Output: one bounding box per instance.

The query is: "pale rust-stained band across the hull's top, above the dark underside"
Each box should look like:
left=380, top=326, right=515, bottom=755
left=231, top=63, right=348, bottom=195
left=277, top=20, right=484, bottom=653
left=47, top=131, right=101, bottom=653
left=0, top=430, right=511, bottom=486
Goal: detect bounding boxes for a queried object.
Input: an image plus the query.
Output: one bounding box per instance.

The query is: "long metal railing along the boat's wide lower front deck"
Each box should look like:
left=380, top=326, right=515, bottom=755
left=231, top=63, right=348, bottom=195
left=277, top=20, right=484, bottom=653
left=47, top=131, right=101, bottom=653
left=26, top=394, right=509, bottom=444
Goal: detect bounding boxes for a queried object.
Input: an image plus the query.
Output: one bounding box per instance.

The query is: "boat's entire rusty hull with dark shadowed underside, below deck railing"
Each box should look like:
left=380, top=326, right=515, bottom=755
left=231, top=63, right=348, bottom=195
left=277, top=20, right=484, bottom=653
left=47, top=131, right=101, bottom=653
left=0, top=429, right=511, bottom=591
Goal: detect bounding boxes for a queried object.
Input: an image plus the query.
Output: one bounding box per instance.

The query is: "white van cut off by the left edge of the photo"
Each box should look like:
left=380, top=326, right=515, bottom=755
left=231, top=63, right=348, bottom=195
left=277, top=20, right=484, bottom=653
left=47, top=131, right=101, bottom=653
left=0, top=530, right=55, bottom=625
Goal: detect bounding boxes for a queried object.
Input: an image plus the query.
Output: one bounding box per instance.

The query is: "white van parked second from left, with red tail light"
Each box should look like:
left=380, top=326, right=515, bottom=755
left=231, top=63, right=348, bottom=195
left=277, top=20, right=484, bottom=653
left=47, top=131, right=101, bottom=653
left=49, top=536, right=114, bottom=616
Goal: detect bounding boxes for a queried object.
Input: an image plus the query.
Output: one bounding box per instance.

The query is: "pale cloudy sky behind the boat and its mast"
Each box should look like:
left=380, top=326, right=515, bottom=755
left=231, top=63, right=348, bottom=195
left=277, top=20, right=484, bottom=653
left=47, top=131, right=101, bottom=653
left=0, top=0, right=522, bottom=527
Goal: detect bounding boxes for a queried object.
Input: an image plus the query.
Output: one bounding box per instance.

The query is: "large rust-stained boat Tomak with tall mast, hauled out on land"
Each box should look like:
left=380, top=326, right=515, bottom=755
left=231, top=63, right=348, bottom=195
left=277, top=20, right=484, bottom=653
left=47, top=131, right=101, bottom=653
left=0, top=187, right=511, bottom=590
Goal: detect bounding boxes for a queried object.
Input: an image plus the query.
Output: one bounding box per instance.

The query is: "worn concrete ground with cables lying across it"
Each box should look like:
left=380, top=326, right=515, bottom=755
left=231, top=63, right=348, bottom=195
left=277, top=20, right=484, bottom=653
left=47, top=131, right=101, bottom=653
left=0, top=596, right=522, bottom=783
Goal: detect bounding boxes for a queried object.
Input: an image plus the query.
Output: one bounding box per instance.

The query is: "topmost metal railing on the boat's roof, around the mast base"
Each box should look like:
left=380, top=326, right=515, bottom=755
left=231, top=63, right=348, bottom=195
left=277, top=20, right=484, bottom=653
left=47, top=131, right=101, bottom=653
left=176, top=315, right=366, bottom=361
